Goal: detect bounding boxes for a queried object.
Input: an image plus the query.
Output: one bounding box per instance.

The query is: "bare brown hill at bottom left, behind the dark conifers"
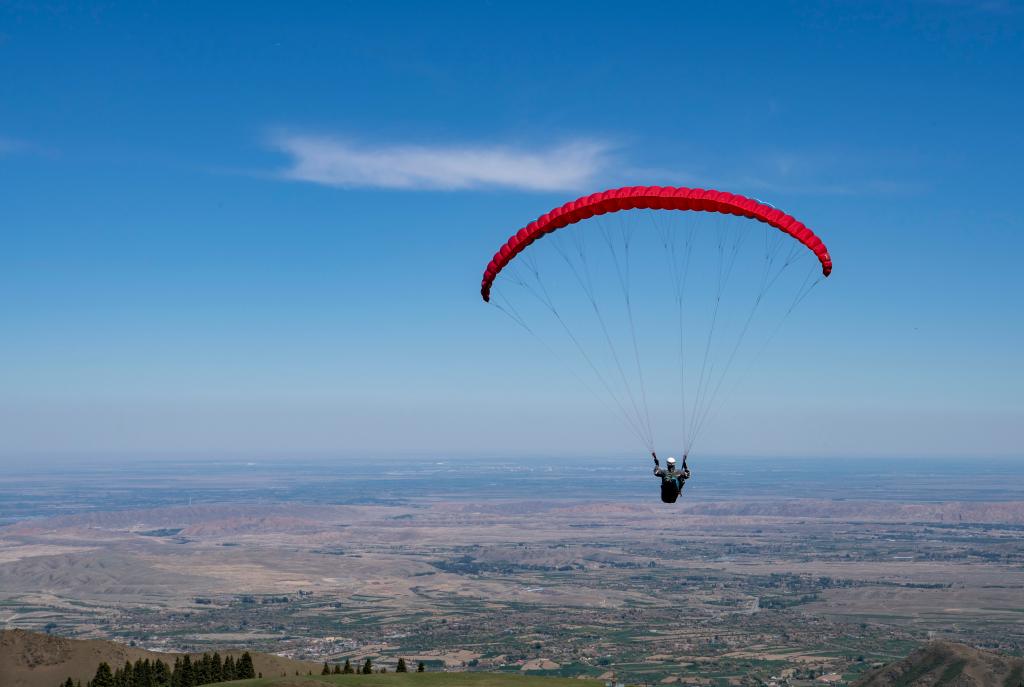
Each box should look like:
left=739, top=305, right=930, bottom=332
left=0, top=630, right=323, bottom=687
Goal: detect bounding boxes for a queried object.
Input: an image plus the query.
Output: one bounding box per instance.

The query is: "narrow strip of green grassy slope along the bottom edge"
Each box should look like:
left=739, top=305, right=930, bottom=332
left=206, top=673, right=604, bottom=687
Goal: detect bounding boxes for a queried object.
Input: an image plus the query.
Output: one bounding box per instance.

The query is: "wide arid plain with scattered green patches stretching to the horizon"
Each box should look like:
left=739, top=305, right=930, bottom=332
left=0, top=460, right=1024, bottom=682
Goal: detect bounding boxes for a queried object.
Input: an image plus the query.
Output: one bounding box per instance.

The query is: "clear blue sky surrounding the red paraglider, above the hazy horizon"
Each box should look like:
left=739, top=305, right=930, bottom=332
left=0, top=0, right=1024, bottom=461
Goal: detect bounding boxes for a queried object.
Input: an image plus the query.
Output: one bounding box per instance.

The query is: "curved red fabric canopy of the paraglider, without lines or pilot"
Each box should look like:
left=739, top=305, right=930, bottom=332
left=480, top=186, right=831, bottom=301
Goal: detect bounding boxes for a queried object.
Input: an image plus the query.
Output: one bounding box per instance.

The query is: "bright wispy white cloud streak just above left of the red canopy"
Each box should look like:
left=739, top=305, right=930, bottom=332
left=271, top=134, right=611, bottom=190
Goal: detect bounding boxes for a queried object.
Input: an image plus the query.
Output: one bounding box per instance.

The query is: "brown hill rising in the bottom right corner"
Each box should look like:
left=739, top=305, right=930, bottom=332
left=854, top=642, right=1024, bottom=687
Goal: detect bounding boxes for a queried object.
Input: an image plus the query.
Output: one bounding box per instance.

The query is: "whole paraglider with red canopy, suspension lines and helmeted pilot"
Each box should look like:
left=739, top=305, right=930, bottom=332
left=480, top=186, right=833, bottom=503
